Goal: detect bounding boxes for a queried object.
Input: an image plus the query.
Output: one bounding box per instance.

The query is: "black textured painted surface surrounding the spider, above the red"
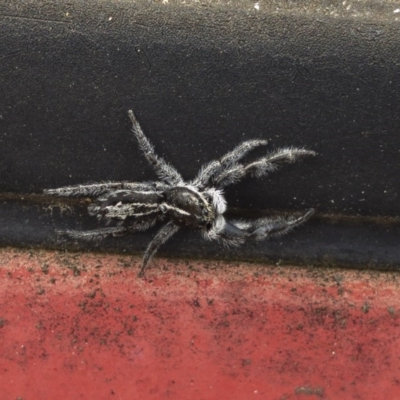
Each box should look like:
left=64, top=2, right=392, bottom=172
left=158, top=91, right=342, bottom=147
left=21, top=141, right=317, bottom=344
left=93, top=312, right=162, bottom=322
left=0, top=0, right=400, bottom=268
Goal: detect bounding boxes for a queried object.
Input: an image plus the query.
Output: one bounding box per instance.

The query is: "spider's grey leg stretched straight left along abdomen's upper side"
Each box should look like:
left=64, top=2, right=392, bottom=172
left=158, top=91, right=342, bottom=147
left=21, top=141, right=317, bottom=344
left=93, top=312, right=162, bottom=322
left=43, top=182, right=163, bottom=197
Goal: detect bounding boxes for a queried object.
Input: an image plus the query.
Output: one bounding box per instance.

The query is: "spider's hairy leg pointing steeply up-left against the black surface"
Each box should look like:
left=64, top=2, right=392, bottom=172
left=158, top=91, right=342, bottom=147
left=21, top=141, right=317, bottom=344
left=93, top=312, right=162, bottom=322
left=128, top=110, right=183, bottom=185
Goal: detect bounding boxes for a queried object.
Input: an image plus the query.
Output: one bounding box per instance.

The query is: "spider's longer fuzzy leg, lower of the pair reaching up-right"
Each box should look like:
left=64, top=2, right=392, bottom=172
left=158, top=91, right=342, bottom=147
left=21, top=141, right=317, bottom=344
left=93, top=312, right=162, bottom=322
left=213, top=147, right=316, bottom=189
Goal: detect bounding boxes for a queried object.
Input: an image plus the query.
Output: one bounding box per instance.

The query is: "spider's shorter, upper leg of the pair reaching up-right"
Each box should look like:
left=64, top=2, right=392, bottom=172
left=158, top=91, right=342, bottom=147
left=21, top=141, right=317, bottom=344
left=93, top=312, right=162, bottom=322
left=191, top=139, right=268, bottom=188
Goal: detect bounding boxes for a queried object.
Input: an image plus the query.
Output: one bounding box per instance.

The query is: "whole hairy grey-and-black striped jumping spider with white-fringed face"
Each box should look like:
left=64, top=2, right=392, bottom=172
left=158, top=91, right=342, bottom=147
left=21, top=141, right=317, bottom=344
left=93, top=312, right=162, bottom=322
left=44, top=110, right=316, bottom=277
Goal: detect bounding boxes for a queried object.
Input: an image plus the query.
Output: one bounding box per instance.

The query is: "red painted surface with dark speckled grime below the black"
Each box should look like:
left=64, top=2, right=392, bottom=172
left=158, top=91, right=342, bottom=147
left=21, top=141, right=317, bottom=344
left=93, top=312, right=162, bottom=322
left=0, top=249, right=400, bottom=400
